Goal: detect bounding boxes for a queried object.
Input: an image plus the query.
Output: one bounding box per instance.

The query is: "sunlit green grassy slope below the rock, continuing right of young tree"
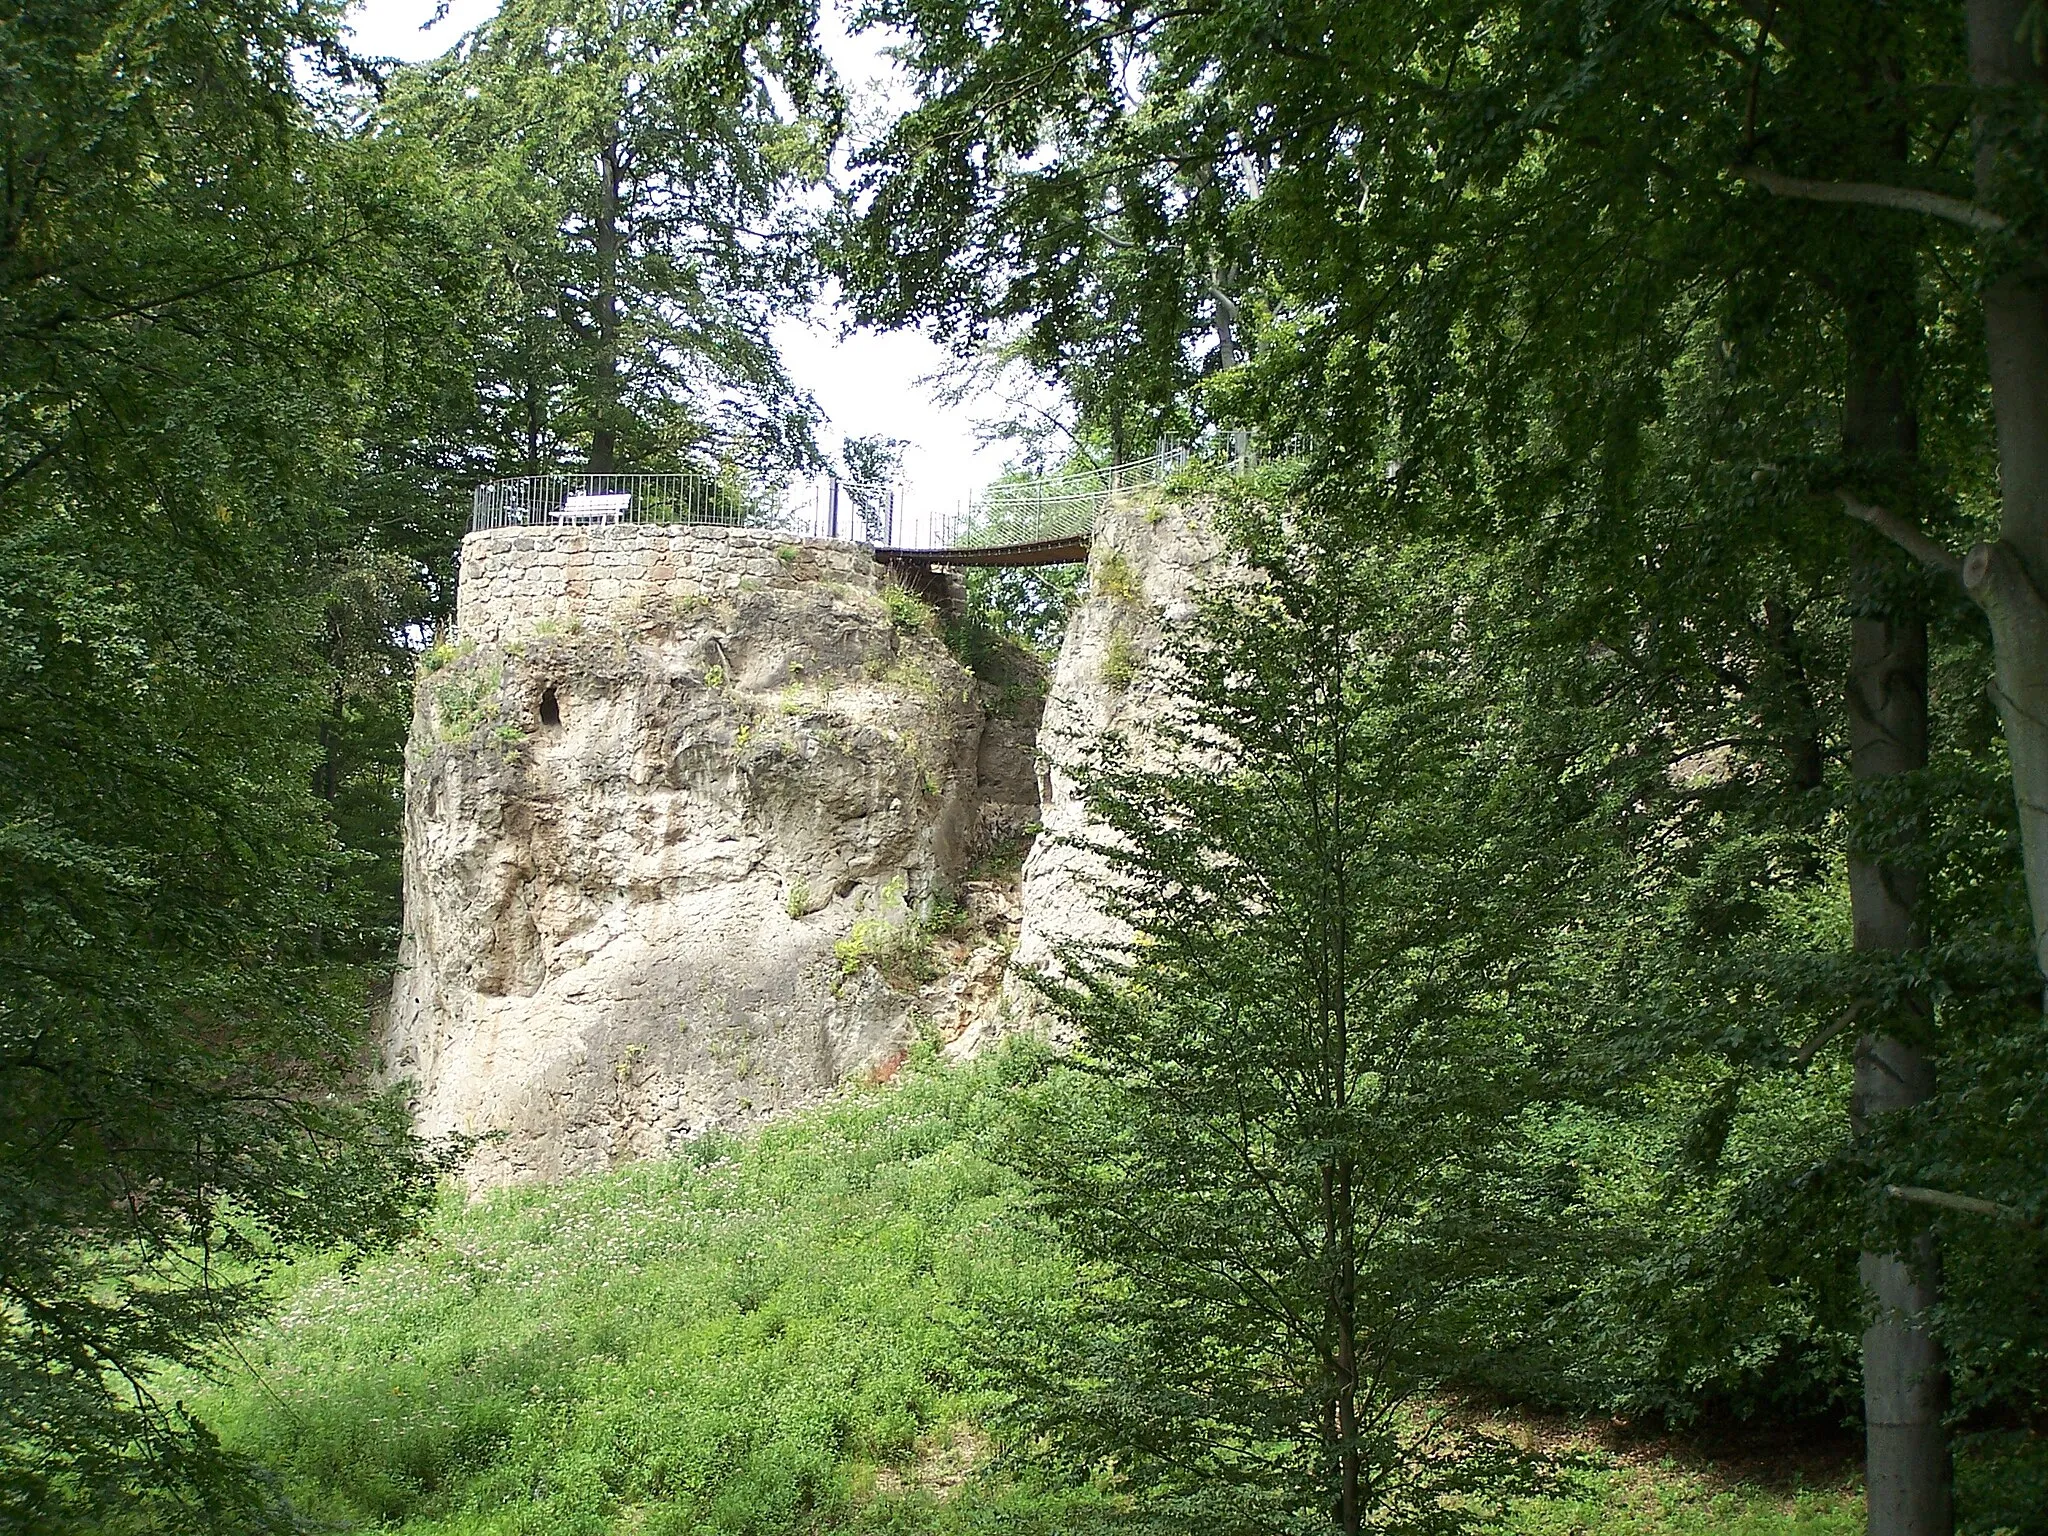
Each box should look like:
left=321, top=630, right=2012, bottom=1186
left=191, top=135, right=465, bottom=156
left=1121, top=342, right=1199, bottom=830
left=186, top=1065, right=1916, bottom=1536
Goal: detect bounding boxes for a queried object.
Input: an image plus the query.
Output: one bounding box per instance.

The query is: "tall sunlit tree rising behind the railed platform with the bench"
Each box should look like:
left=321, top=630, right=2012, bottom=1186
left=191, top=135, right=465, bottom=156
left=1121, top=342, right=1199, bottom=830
left=381, top=0, right=838, bottom=473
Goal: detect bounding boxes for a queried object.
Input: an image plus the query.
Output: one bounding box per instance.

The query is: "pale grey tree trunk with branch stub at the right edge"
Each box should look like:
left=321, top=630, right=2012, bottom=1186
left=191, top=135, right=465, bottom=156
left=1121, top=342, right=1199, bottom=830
left=1962, top=0, right=2048, bottom=1011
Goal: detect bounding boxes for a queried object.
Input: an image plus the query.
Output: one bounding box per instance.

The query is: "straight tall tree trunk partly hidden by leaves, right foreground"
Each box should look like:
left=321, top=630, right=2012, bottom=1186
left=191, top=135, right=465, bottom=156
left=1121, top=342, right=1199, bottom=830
left=1841, top=270, right=1954, bottom=1536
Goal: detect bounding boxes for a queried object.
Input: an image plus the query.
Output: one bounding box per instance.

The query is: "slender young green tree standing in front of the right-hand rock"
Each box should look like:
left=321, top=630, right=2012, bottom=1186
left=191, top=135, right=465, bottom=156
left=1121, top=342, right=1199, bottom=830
left=1014, top=502, right=1544, bottom=1532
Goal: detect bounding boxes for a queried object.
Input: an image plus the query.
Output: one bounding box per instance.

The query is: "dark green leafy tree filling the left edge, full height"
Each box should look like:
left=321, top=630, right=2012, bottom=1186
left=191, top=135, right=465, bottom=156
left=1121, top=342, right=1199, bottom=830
left=0, top=0, right=452, bottom=1532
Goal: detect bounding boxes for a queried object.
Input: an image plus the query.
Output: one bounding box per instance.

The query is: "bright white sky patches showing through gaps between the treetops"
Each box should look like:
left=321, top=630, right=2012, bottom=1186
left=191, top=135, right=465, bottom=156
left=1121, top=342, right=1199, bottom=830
left=350, top=0, right=1040, bottom=510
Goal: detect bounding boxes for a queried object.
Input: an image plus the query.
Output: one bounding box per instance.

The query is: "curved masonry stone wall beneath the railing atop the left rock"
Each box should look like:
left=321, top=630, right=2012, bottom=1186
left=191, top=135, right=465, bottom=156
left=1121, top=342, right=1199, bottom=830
left=455, top=522, right=881, bottom=645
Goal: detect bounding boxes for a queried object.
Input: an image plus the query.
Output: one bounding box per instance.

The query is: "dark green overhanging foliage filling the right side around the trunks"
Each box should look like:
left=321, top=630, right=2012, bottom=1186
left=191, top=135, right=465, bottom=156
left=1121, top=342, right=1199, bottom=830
left=846, top=0, right=2048, bottom=1482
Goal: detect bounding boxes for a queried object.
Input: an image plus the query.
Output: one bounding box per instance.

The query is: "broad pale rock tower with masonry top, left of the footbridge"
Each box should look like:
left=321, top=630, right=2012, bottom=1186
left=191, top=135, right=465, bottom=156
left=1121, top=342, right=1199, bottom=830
left=385, top=526, right=1036, bottom=1182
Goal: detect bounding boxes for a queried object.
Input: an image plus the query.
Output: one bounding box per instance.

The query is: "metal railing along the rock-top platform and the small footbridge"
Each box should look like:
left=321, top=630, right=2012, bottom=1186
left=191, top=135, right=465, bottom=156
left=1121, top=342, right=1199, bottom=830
left=469, top=432, right=1305, bottom=553
